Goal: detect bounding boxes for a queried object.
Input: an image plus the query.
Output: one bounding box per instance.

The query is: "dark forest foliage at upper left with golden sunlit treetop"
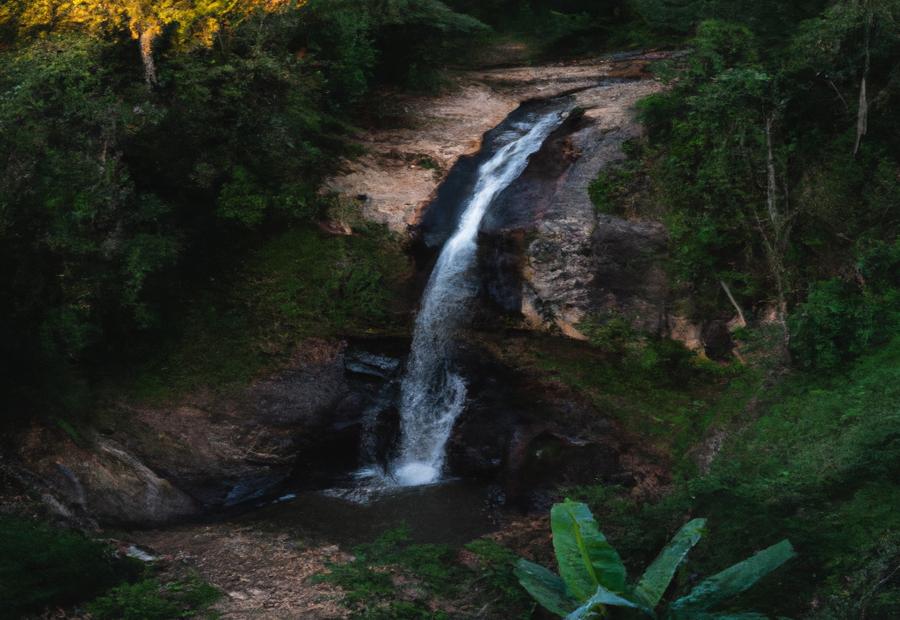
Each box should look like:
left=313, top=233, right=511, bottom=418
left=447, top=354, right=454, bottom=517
left=0, top=0, right=486, bottom=416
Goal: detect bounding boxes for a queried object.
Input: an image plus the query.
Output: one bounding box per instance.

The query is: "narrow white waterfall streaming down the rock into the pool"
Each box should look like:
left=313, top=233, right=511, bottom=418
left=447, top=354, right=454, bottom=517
left=388, top=110, right=563, bottom=486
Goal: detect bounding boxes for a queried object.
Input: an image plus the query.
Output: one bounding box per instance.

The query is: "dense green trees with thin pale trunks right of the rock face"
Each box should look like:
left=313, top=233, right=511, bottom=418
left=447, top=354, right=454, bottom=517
left=592, top=0, right=900, bottom=369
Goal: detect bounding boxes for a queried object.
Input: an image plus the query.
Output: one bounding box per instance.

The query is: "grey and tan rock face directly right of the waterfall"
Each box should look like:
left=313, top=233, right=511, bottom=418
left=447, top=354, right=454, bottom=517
left=472, top=74, right=731, bottom=358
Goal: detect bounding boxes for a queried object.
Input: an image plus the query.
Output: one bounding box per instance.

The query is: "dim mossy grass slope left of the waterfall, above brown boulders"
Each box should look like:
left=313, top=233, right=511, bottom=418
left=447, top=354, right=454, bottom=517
left=114, top=226, right=411, bottom=402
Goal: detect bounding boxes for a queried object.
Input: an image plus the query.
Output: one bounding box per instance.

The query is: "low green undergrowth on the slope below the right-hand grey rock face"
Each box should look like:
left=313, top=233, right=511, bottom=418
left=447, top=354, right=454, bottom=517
left=531, top=318, right=777, bottom=476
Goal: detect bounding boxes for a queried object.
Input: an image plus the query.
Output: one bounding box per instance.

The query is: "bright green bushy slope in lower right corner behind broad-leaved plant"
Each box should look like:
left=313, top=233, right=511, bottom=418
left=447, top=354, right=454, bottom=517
left=570, top=338, right=900, bottom=618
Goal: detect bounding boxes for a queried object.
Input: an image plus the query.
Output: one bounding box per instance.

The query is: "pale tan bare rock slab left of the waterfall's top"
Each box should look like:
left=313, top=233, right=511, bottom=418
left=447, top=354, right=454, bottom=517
left=327, top=54, right=672, bottom=232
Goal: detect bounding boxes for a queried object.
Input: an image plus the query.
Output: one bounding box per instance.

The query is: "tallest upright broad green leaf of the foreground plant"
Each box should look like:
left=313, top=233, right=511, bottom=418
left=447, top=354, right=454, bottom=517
left=550, top=500, right=625, bottom=601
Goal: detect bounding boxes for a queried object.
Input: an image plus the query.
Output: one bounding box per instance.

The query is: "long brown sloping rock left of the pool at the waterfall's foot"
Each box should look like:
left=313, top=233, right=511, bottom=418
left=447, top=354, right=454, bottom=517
left=18, top=341, right=356, bottom=524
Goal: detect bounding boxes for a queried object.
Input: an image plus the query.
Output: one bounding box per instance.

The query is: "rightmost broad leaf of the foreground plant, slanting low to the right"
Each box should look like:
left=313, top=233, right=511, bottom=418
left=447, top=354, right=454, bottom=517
left=672, top=540, right=797, bottom=617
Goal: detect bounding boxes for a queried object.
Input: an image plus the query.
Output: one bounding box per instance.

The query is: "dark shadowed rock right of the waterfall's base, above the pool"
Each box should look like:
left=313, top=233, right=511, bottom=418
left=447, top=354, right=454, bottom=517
left=448, top=340, right=667, bottom=507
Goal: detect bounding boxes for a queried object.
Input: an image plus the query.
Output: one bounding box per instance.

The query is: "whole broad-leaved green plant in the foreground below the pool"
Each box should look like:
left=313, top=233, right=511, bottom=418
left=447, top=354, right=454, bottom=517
left=516, top=500, right=795, bottom=620
